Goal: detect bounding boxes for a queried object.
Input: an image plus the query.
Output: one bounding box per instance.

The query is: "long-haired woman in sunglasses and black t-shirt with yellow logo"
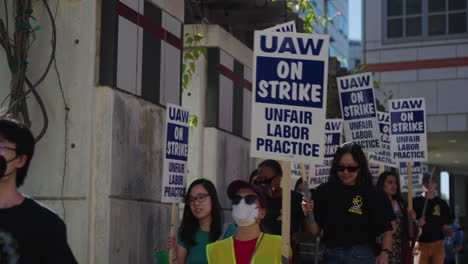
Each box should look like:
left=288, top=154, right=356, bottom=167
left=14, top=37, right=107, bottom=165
left=303, top=142, right=393, bottom=264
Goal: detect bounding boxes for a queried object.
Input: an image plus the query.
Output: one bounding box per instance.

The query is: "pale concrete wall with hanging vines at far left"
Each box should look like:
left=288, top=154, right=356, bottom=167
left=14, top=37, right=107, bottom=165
left=0, top=0, right=97, bottom=263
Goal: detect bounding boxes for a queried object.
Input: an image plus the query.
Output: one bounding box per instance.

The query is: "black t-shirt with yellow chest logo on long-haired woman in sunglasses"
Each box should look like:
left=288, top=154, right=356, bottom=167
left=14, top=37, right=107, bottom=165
left=312, top=182, right=394, bottom=248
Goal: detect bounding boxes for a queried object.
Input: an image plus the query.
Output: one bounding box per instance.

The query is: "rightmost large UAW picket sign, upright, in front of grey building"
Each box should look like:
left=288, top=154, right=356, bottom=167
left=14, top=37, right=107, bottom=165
left=389, top=98, right=427, bottom=162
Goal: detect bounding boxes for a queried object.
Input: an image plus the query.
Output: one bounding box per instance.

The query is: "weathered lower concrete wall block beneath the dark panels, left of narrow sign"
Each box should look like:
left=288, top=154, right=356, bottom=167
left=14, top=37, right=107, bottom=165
left=90, top=87, right=171, bottom=263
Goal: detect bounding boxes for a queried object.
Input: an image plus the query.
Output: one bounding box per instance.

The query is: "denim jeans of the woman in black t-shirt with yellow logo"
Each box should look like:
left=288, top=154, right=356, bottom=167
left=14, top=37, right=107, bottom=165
left=322, top=244, right=375, bottom=264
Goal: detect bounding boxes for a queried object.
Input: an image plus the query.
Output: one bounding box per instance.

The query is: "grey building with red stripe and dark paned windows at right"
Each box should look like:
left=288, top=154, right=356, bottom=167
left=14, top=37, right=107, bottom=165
left=363, top=0, right=468, bottom=241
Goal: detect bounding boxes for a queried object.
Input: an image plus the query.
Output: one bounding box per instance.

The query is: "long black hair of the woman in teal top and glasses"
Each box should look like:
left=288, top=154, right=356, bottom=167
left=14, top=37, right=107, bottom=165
left=179, top=179, right=221, bottom=248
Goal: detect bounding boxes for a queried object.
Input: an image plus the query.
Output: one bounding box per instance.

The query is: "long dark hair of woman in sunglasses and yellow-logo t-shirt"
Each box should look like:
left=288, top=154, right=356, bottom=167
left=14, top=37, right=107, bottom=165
left=328, top=142, right=374, bottom=186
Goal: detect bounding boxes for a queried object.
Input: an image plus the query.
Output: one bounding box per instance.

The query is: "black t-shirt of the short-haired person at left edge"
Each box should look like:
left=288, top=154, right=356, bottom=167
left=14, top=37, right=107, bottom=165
left=0, top=198, right=77, bottom=264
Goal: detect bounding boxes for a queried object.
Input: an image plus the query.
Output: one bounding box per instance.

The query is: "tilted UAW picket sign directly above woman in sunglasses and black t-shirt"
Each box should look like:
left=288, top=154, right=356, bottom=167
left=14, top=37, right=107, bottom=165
left=337, top=72, right=380, bottom=152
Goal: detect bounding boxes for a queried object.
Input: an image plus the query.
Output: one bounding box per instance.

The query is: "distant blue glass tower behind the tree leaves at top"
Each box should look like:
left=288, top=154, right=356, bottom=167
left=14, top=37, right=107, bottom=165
left=311, top=0, right=361, bottom=69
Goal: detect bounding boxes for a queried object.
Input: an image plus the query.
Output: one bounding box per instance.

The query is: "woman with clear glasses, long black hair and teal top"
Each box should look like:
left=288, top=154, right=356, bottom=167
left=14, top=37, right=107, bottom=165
left=168, top=179, right=237, bottom=264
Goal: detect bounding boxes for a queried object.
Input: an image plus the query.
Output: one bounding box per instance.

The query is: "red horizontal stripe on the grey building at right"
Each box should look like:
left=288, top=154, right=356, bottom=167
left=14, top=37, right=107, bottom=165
left=366, top=57, right=468, bottom=72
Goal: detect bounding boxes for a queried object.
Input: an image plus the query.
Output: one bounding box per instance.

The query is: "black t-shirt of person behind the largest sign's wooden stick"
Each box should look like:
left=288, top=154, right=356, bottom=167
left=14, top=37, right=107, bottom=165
left=262, top=191, right=305, bottom=235
